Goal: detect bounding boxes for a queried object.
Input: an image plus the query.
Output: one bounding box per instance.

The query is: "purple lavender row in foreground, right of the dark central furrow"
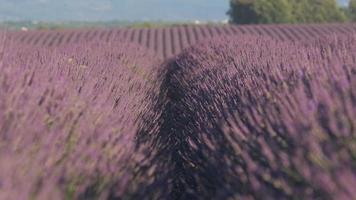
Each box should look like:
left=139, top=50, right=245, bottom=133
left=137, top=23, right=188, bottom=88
left=152, top=36, right=356, bottom=199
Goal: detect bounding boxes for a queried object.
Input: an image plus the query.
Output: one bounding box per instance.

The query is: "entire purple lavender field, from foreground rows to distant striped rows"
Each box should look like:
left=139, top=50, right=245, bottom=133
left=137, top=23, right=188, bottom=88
left=0, top=24, right=356, bottom=200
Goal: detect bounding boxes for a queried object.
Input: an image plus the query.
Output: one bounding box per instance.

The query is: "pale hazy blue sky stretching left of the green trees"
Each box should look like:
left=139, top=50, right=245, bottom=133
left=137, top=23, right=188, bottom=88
left=0, top=0, right=229, bottom=21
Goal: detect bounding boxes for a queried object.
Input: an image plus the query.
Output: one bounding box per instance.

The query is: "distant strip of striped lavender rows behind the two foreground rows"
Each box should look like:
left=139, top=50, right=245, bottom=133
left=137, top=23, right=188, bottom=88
left=11, top=24, right=356, bottom=59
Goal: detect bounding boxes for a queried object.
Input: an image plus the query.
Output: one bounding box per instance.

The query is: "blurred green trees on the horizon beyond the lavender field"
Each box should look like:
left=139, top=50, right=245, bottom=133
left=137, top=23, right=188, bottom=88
left=228, top=0, right=356, bottom=24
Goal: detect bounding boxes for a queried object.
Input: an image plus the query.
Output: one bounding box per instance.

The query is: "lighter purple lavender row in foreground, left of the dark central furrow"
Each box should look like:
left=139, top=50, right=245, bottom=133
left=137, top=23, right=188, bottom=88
left=0, top=38, right=163, bottom=200
